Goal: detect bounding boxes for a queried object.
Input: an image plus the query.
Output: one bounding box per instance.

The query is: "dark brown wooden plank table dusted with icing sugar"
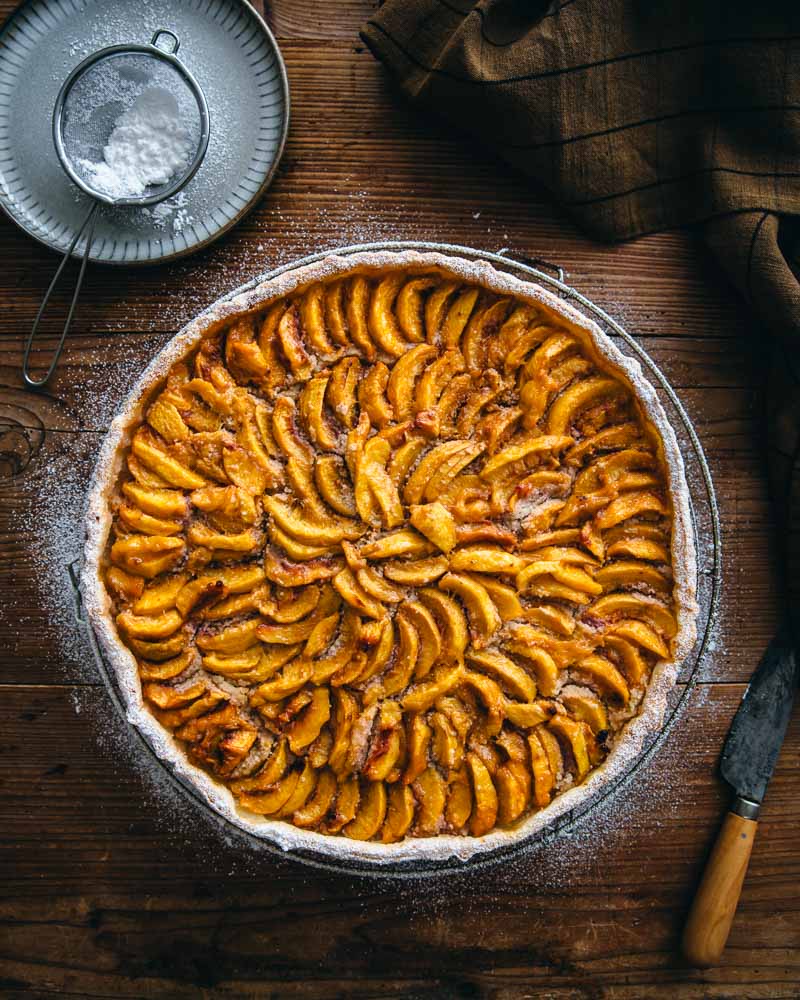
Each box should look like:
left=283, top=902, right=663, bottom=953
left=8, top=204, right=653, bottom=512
left=0, top=0, right=800, bottom=998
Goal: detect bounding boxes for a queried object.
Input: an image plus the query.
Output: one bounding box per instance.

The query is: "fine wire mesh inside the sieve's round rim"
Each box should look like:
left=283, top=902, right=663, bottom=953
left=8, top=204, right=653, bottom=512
left=57, top=50, right=204, bottom=204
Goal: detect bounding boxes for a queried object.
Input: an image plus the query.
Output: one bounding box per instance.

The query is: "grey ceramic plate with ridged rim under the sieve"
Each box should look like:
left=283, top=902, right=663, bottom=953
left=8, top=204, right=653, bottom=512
left=0, top=0, right=289, bottom=264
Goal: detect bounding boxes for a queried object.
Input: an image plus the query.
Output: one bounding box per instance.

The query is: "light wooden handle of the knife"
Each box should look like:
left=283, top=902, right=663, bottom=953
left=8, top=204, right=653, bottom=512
left=683, top=799, right=758, bottom=967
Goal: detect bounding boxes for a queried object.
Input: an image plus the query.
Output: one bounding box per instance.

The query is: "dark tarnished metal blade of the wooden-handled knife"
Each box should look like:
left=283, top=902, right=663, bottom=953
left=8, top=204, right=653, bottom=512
left=719, top=626, right=797, bottom=819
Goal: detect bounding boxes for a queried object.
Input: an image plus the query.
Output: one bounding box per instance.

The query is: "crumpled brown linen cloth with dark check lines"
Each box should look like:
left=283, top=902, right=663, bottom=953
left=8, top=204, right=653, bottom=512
left=362, top=0, right=800, bottom=636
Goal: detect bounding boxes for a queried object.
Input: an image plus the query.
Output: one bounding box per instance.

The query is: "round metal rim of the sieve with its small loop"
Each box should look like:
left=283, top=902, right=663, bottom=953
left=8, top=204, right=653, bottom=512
left=53, top=28, right=211, bottom=207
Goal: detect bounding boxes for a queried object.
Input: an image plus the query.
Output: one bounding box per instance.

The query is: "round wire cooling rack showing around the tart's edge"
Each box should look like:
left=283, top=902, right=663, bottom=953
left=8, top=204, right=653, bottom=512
left=68, top=241, right=722, bottom=879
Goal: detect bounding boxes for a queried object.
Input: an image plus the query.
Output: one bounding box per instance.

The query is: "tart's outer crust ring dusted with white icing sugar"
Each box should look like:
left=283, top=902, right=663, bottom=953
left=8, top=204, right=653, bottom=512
left=82, top=250, right=697, bottom=864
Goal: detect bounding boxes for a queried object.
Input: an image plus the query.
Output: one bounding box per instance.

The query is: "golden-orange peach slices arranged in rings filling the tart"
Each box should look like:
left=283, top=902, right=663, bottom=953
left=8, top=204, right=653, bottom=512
left=106, top=271, right=676, bottom=843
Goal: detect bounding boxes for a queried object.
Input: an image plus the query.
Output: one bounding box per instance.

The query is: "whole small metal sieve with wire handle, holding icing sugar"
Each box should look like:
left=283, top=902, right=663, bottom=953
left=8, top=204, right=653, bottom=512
left=22, top=28, right=210, bottom=387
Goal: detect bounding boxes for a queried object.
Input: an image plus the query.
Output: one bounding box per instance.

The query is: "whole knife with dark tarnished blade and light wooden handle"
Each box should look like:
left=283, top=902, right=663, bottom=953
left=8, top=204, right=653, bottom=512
left=683, top=626, right=797, bottom=966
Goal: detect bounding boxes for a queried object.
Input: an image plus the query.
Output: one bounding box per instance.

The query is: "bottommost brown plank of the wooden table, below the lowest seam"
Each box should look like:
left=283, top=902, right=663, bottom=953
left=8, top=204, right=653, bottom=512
left=0, top=685, right=800, bottom=998
